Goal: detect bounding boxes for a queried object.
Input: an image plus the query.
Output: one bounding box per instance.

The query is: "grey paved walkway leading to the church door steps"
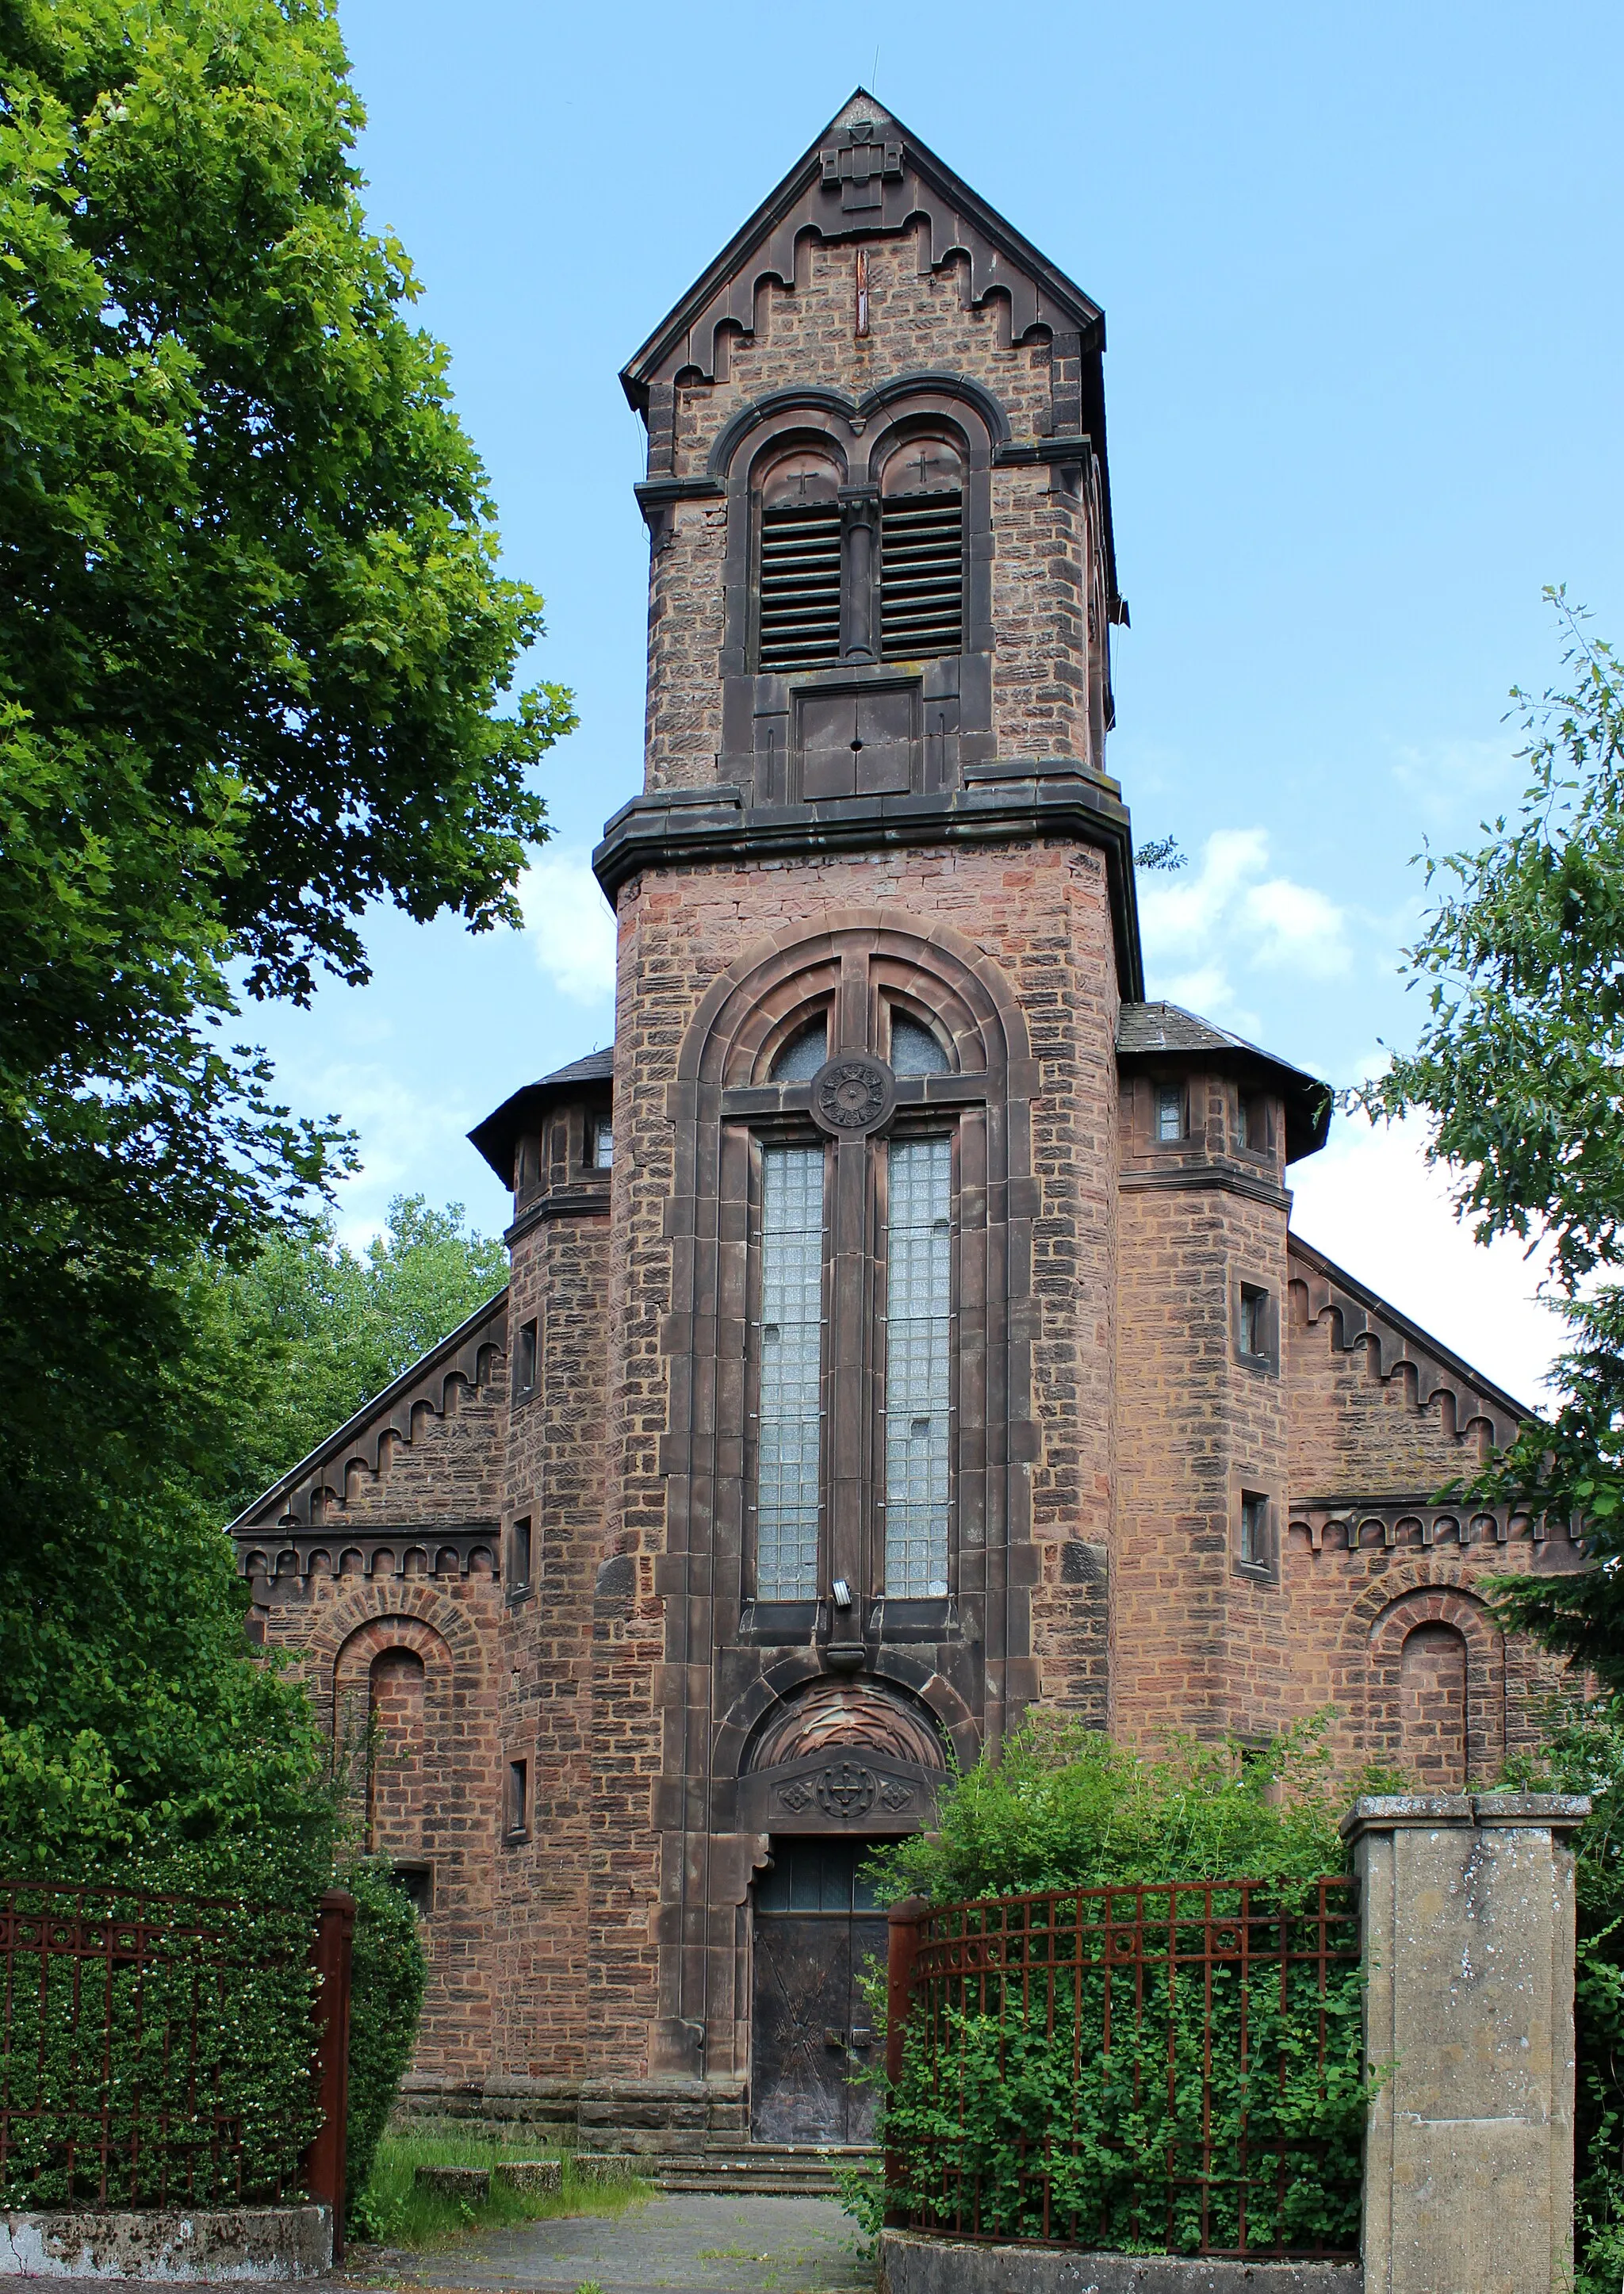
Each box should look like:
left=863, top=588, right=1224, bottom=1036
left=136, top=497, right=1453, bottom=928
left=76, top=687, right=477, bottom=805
left=366, top=2197, right=874, bottom=2294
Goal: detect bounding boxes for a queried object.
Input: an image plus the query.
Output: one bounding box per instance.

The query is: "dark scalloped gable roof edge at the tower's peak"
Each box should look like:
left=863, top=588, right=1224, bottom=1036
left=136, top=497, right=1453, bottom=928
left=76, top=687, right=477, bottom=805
left=619, top=87, right=1117, bottom=608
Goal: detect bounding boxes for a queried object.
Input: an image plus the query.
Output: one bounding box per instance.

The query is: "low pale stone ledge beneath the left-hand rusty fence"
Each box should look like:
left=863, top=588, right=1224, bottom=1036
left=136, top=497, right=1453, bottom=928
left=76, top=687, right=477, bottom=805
left=0, top=2207, right=332, bottom=2284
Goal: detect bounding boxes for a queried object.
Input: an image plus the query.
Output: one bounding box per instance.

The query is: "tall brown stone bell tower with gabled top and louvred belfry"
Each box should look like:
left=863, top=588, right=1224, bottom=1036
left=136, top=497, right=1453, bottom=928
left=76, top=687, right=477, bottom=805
left=588, top=92, right=1143, bottom=2110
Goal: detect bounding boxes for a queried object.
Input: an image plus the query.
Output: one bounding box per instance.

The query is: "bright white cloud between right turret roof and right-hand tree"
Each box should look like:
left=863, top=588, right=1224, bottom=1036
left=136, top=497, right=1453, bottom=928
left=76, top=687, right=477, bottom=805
left=1289, top=1115, right=1562, bottom=1404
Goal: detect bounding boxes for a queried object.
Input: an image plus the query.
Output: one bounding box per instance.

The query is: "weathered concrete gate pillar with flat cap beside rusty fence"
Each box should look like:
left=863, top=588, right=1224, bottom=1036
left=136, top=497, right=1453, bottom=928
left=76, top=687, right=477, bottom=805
left=1342, top=1791, right=1590, bottom=2294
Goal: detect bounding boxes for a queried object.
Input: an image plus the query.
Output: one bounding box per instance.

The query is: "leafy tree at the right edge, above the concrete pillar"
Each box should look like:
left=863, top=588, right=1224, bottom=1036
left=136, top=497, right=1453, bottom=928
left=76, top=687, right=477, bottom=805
left=1356, top=590, right=1624, bottom=1688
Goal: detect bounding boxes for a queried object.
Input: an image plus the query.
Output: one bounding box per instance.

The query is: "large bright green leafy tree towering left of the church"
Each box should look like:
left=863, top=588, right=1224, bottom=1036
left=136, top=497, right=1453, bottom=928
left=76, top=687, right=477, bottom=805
left=0, top=0, right=573, bottom=1886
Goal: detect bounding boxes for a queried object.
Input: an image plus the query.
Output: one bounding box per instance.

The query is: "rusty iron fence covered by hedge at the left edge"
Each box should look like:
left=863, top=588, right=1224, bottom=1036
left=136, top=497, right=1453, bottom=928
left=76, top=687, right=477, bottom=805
left=0, top=1878, right=353, bottom=2250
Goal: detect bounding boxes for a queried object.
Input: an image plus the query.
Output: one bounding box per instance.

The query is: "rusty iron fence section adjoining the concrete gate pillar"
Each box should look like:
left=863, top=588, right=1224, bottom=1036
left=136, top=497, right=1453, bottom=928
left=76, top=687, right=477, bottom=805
left=886, top=1878, right=1367, bottom=2258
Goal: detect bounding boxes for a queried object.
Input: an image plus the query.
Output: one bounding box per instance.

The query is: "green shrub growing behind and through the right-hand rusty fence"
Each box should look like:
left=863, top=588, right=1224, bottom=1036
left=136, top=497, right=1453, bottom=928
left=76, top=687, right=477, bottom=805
left=862, top=1714, right=1367, bottom=2253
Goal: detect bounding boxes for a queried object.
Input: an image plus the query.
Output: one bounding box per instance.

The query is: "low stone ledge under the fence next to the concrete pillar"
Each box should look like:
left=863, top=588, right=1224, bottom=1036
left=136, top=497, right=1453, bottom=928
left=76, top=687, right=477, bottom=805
left=879, top=2230, right=1365, bottom=2294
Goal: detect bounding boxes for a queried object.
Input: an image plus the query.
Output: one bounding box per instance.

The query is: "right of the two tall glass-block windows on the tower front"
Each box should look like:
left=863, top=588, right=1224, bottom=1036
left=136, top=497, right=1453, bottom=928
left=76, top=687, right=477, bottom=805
left=886, top=1140, right=952, bottom=1601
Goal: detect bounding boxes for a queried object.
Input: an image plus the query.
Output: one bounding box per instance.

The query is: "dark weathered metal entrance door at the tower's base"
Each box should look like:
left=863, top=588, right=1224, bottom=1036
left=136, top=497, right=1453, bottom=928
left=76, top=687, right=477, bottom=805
left=750, top=1840, right=886, bottom=2143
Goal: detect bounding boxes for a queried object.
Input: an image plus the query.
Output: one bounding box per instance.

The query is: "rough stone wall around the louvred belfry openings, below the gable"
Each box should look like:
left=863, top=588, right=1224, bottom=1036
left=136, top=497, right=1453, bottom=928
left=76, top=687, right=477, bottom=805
left=647, top=234, right=1092, bottom=791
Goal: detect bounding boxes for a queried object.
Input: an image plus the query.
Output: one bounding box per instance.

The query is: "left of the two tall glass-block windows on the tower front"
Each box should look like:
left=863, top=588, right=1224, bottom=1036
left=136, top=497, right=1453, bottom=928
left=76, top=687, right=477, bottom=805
left=755, top=1147, right=823, bottom=1601
